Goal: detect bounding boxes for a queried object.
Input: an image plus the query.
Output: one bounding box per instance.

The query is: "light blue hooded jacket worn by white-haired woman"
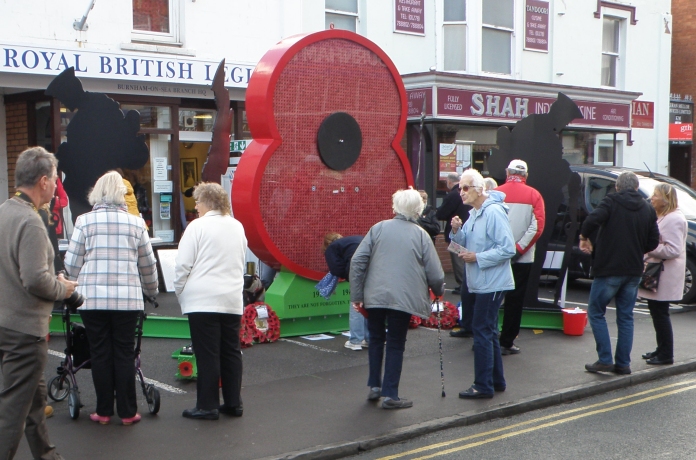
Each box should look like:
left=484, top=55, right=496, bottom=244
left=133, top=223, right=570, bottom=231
left=450, top=190, right=515, bottom=294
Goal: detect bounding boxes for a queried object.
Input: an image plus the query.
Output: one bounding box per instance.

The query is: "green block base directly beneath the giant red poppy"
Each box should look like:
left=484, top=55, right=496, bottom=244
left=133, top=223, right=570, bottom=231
left=266, top=270, right=350, bottom=337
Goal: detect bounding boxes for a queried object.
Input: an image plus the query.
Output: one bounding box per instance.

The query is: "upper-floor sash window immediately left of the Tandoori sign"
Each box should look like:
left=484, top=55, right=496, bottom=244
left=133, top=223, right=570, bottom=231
left=481, top=0, right=515, bottom=75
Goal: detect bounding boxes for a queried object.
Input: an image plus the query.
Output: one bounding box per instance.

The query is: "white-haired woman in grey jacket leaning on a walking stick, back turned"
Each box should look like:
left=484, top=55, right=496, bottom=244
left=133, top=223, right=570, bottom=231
left=350, top=189, right=446, bottom=409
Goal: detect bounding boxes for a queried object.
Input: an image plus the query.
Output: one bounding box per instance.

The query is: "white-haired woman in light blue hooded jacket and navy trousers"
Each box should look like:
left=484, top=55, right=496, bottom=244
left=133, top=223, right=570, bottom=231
left=450, top=169, right=515, bottom=399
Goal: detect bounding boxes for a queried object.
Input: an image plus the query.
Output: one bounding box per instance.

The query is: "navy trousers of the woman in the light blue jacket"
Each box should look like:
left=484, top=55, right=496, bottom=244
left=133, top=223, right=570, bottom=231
left=472, top=291, right=505, bottom=394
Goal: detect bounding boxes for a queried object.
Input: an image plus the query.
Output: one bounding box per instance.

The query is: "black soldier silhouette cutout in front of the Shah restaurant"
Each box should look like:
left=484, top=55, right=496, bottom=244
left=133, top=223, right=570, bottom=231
left=488, top=93, right=583, bottom=308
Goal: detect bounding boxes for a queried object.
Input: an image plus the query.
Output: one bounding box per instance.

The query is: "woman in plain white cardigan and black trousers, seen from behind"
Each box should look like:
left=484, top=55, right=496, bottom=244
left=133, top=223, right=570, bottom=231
left=174, top=183, right=247, bottom=420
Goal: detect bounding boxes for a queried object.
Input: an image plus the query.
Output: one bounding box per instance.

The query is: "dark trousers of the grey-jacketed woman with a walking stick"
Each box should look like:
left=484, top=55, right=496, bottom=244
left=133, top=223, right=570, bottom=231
left=367, top=308, right=411, bottom=399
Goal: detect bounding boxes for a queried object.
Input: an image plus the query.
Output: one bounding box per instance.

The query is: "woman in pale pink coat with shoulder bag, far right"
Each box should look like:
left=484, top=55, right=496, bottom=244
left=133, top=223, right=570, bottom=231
left=638, top=183, right=688, bottom=364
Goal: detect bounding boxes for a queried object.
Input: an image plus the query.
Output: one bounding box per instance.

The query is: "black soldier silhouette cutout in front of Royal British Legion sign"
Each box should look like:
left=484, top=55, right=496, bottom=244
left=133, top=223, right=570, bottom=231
left=46, top=67, right=150, bottom=223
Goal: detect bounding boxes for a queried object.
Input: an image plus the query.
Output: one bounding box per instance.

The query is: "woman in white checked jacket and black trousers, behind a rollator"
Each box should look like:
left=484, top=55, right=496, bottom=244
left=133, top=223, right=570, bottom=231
left=65, top=171, right=157, bottom=425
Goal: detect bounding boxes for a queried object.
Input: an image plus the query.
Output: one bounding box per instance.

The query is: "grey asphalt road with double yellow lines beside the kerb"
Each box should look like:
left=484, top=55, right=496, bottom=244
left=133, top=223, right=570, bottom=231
left=349, top=374, right=696, bottom=460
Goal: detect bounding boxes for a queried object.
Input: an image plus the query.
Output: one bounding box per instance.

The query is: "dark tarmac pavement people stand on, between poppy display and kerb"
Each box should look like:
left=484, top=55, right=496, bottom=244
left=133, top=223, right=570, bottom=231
left=25, top=274, right=696, bottom=459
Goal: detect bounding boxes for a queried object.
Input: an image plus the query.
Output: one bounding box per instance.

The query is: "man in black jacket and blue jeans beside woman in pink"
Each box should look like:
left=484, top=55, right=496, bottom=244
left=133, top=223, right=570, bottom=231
left=580, top=172, right=660, bottom=374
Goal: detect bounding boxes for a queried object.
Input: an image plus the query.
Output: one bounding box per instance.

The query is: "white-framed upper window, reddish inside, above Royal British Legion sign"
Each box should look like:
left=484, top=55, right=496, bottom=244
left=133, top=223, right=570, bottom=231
left=132, top=0, right=180, bottom=44
